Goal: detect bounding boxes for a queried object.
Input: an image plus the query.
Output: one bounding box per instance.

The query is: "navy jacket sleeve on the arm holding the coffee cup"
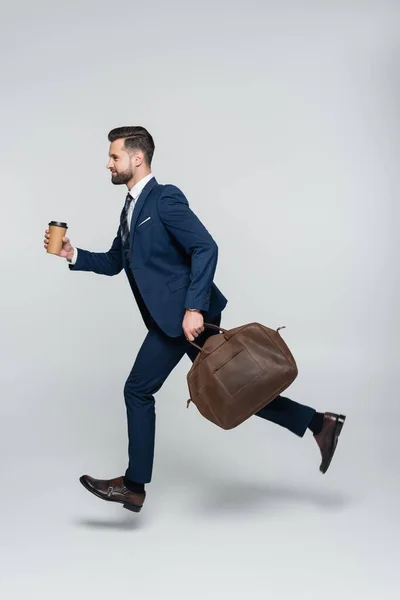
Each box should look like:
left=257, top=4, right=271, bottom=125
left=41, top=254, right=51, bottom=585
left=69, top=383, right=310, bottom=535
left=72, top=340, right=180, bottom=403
left=68, top=227, right=123, bottom=276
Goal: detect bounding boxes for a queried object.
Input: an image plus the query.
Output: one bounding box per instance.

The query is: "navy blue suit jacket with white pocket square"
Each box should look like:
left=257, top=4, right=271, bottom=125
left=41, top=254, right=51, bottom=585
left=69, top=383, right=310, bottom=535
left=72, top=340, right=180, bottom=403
left=69, top=178, right=227, bottom=337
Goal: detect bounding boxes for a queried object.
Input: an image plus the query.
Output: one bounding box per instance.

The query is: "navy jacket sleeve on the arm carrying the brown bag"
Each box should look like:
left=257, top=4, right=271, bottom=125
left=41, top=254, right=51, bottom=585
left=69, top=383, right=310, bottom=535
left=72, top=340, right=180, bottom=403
left=158, top=185, right=218, bottom=311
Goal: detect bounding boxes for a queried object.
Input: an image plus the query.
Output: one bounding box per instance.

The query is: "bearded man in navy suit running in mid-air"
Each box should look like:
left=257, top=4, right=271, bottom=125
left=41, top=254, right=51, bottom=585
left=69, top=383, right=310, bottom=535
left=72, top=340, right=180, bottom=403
left=45, top=126, right=345, bottom=512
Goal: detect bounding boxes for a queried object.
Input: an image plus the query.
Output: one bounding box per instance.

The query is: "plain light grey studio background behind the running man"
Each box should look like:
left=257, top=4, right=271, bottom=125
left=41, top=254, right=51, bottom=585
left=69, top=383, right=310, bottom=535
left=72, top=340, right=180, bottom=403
left=0, top=0, right=400, bottom=600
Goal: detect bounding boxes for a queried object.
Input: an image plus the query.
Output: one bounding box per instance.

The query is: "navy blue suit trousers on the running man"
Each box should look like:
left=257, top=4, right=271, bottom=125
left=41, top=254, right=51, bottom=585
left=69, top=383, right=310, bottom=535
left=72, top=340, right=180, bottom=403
left=124, top=314, right=315, bottom=483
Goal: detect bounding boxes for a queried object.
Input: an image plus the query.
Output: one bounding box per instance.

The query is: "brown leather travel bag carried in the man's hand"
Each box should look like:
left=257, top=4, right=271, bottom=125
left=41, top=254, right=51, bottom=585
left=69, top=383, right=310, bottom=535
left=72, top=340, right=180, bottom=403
left=187, top=323, right=298, bottom=429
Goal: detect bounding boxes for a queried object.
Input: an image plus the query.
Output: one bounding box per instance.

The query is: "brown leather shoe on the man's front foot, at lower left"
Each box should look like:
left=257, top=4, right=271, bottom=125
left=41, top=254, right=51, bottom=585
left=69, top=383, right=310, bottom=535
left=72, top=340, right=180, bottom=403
left=79, top=475, right=146, bottom=512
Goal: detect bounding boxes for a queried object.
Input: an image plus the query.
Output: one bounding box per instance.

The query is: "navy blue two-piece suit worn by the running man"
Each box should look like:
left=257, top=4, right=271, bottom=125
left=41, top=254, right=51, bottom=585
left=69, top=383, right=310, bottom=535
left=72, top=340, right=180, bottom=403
left=69, top=178, right=315, bottom=483
